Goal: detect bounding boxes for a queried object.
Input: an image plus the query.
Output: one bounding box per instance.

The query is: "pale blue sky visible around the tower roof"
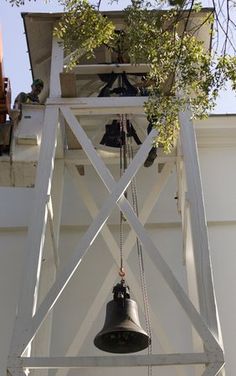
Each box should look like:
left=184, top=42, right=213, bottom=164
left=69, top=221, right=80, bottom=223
left=0, top=0, right=236, bottom=113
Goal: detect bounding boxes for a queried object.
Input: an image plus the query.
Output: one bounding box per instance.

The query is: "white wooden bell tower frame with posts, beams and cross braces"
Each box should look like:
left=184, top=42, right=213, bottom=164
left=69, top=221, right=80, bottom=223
left=4, top=10, right=224, bottom=376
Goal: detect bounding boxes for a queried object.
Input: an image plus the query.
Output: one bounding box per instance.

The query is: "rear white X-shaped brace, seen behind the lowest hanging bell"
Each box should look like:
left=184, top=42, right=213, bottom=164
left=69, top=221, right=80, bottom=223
left=64, top=164, right=185, bottom=376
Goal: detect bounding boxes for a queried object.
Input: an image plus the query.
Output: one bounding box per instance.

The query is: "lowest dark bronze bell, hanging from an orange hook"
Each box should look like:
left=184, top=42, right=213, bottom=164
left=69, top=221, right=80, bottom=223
left=94, top=280, right=150, bottom=354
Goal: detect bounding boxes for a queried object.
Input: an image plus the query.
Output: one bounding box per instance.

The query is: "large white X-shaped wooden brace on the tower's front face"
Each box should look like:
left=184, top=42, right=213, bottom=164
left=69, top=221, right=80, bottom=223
left=17, top=107, right=221, bottom=356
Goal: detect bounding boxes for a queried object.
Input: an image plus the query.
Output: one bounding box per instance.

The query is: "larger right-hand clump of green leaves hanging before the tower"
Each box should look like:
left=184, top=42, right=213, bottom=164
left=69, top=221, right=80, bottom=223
left=127, top=3, right=214, bottom=151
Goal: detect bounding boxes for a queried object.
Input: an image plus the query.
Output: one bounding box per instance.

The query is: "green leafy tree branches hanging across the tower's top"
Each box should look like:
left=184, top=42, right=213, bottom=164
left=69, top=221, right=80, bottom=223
left=6, top=0, right=236, bottom=152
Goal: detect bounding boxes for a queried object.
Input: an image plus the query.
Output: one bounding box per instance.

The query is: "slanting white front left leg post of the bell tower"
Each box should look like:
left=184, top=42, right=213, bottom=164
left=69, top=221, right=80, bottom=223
left=7, top=108, right=58, bottom=357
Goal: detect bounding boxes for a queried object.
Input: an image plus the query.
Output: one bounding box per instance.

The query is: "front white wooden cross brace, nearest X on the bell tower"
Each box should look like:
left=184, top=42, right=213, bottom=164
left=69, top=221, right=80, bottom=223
left=7, top=106, right=223, bottom=376
